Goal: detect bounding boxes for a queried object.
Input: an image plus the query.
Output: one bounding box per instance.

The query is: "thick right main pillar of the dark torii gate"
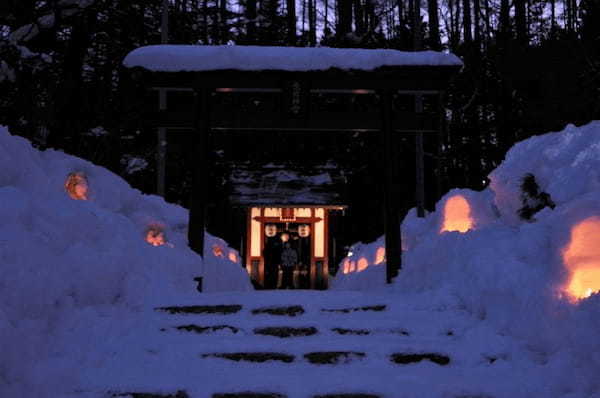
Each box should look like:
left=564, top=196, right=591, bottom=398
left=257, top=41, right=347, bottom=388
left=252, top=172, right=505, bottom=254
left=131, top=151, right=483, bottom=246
left=381, top=89, right=402, bottom=283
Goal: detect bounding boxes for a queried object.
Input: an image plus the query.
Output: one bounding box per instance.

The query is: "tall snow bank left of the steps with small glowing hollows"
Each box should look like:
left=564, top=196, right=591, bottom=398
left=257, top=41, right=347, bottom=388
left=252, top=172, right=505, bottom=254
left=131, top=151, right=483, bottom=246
left=0, top=128, right=251, bottom=397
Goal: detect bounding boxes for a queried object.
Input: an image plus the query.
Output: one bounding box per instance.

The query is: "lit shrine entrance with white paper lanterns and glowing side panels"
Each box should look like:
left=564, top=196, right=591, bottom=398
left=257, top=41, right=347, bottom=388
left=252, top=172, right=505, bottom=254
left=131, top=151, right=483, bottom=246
left=246, top=205, right=343, bottom=289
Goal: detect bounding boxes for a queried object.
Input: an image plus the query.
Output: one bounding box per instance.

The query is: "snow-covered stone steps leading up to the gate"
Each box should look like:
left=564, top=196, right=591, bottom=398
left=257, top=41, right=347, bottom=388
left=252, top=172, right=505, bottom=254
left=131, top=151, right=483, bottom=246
left=94, top=291, right=518, bottom=398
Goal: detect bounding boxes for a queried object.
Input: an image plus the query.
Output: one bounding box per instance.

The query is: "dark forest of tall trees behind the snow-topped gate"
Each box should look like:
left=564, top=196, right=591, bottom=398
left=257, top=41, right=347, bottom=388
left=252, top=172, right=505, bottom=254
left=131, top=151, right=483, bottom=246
left=0, top=0, right=600, bottom=199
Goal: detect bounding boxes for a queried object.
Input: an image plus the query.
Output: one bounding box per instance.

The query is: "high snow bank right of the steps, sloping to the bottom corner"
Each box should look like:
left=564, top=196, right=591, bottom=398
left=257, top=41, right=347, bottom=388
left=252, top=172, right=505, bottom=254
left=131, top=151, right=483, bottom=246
left=332, top=122, right=600, bottom=397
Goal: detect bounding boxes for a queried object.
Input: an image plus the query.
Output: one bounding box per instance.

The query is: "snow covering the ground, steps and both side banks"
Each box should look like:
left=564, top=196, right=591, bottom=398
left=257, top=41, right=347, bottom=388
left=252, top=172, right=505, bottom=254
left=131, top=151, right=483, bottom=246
left=0, top=122, right=600, bottom=398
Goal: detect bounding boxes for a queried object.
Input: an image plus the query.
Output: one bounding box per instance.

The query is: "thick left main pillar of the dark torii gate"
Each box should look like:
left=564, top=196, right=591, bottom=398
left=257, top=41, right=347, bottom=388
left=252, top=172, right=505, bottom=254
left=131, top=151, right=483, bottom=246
left=188, top=87, right=210, bottom=258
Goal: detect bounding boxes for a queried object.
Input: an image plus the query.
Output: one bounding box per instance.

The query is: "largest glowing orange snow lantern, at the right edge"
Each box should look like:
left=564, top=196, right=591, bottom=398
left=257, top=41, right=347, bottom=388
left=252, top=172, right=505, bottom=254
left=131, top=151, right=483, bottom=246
left=562, top=217, right=600, bottom=300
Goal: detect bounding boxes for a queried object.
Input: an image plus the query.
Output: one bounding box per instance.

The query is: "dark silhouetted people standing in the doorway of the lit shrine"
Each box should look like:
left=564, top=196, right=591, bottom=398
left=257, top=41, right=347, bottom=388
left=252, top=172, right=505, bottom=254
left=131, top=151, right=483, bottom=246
left=264, top=233, right=308, bottom=289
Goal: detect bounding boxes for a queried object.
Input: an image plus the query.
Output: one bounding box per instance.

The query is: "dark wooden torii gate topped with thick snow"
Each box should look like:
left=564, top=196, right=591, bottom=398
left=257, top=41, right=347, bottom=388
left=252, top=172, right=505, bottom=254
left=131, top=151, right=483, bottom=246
left=123, top=45, right=462, bottom=283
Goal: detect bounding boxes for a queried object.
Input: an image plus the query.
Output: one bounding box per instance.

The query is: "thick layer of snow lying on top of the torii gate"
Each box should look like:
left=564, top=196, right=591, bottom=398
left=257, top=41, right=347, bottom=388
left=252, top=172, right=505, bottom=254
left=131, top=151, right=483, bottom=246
left=123, top=45, right=462, bottom=72
